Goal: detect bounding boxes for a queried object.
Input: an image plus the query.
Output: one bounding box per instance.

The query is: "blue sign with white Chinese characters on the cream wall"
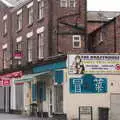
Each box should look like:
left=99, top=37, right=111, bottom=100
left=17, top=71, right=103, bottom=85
left=70, top=75, right=107, bottom=93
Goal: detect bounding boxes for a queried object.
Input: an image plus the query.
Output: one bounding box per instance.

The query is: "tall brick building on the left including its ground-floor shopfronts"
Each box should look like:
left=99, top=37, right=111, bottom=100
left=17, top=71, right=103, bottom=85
left=0, top=0, right=87, bottom=116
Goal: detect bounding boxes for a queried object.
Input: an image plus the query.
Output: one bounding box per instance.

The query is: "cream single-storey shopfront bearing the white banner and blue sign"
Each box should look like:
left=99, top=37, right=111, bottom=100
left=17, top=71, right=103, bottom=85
left=64, top=54, right=120, bottom=120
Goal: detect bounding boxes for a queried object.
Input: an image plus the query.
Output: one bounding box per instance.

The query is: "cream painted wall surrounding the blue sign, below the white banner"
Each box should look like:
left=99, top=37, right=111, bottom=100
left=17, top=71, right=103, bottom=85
left=63, top=70, right=120, bottom=120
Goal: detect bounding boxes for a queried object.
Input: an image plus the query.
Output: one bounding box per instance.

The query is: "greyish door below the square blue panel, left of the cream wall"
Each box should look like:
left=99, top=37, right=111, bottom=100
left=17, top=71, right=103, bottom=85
left=54, top=85, right=63, bottom=113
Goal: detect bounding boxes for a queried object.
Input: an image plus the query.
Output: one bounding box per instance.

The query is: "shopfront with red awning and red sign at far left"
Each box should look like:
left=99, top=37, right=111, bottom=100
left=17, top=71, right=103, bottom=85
left=0, top=71, right=23, bottom=112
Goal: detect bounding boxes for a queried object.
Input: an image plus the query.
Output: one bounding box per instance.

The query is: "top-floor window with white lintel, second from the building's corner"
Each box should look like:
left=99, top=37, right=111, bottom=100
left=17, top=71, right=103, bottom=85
left=27, top=2, right=33, bottom=25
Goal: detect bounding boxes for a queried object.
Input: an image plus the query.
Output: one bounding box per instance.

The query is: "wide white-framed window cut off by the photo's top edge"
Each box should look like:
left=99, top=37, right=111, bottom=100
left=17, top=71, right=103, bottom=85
left=60, top=0, right=76, bottom=7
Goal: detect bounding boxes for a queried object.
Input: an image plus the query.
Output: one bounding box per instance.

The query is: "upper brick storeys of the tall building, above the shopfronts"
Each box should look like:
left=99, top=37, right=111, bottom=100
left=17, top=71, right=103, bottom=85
left=0, top=0, right=86, bottom=69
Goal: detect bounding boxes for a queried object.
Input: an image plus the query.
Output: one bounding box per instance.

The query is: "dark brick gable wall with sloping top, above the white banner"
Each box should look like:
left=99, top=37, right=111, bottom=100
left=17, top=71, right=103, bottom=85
left=89, top=16, right=120, bottom=53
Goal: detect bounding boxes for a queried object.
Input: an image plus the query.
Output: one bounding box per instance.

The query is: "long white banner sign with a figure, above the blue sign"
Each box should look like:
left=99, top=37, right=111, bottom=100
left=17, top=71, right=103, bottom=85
left=68, top=54, right=120, bottom=74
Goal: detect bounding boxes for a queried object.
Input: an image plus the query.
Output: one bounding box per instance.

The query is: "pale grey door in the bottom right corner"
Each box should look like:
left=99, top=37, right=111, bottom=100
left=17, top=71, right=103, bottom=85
left=110, top=94, right=120, bottom=120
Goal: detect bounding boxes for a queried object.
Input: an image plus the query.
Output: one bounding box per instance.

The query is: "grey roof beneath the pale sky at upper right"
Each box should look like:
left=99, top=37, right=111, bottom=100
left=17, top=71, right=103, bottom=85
left=87, top=11, right=120, bottom=22
